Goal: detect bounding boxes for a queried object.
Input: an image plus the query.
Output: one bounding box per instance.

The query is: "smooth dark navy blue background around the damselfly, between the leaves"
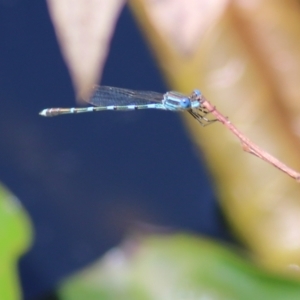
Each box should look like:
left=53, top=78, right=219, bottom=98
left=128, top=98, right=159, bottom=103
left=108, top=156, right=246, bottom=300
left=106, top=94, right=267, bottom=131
left=0, top=0, right=227, bottom=299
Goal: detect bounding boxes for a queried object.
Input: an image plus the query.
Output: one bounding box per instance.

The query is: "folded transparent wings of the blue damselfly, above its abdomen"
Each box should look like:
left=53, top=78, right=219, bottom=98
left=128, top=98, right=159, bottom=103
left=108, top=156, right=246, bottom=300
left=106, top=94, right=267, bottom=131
left=85, top=86, right=164, bottom=106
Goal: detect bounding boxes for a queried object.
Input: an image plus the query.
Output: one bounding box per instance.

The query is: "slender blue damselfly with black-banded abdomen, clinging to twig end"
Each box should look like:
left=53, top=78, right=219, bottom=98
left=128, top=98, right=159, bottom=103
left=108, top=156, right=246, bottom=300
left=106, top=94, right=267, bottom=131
left=40, top=86, right=215, bottom=126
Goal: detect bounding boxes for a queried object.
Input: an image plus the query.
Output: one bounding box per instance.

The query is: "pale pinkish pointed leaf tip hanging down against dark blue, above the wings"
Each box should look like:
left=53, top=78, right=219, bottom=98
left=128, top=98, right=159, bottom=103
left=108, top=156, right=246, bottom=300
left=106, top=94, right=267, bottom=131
left=48, top=0, right=125, bottom=99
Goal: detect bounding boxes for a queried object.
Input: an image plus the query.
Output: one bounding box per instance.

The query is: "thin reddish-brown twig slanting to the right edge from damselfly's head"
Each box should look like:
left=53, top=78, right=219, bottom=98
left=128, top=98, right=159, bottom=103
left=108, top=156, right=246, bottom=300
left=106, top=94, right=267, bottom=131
left=200, top=96, right=300, bottom=182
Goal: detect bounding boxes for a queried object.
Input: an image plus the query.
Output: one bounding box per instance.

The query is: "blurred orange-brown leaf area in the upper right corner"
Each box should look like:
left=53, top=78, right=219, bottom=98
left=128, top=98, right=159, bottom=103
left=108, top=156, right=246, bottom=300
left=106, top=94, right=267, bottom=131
left=235, top=1, right=300, bottom=137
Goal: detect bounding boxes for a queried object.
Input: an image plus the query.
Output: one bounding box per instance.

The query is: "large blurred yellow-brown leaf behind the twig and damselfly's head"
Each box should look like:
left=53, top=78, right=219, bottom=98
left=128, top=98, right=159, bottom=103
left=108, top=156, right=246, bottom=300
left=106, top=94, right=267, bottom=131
left=131, top=0, right=300, bottom=276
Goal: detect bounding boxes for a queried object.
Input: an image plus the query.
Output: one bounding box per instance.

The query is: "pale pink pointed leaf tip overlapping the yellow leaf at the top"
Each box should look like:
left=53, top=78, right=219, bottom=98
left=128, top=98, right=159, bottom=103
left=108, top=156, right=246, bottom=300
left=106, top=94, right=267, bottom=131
left=139, top=0, right=229, bottom=54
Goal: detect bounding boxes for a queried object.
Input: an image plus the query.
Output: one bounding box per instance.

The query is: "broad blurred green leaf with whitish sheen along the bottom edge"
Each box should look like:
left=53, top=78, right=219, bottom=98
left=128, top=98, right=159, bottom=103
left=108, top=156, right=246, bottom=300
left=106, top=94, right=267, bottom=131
left=59, top=235, right=300, bottom=300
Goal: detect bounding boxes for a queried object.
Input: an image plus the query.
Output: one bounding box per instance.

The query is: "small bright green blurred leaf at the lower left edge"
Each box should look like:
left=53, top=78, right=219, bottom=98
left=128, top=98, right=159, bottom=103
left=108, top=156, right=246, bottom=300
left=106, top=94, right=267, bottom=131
left=0, top=185, right=32, bottom=300
